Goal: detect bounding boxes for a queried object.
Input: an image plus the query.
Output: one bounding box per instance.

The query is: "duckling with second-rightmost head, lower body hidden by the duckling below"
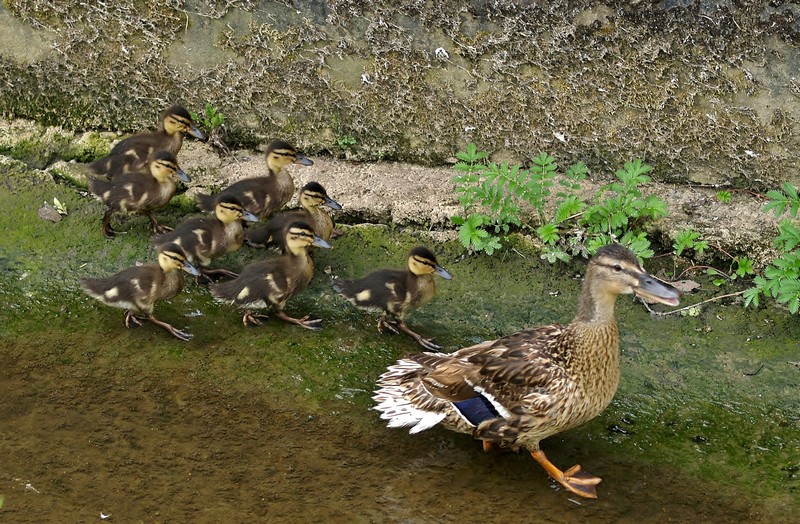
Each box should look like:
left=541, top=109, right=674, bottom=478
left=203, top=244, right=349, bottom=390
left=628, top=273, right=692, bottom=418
left=244, top=182, right=342, bottom=252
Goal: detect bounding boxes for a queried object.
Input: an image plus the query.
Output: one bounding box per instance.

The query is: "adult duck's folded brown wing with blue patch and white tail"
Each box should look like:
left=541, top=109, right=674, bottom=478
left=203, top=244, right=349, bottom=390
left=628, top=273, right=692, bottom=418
left=374, top=325, right=572, bottom=444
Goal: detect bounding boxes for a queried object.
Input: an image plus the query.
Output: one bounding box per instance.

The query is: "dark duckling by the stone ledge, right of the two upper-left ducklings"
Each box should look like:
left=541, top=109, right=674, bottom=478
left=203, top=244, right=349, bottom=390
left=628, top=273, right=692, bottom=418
left=197, top=140, right=314, bottom=220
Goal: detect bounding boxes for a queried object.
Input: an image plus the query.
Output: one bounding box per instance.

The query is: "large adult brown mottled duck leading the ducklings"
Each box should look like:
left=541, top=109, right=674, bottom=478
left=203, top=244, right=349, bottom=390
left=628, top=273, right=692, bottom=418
left=373, top=245, right=680, bottom=498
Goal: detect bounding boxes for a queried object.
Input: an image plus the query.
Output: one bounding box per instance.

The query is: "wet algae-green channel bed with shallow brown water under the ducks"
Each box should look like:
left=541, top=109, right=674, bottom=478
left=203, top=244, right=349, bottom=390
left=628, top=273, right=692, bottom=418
left=0, top=170, right=800, bottom=523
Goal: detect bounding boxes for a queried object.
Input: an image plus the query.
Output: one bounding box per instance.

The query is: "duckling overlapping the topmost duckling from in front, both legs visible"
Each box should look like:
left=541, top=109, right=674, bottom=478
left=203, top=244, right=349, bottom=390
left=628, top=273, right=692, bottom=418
left=89, top=151, right=191, bottom=238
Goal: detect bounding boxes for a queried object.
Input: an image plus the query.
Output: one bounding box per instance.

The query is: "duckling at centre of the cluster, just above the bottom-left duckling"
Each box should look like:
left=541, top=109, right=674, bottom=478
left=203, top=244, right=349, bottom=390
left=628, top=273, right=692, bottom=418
left=153, top=196, right=258, bottom=279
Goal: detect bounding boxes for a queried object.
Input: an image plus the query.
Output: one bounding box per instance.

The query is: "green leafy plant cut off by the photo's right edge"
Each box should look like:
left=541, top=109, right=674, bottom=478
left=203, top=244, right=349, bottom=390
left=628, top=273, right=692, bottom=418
left=744, top=182, right=800, bottom=314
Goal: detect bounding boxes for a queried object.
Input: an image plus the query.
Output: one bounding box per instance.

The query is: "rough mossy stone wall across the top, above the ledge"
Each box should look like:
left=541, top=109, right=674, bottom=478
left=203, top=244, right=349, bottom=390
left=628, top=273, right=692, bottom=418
left=0, top=0, right=800, bottom=188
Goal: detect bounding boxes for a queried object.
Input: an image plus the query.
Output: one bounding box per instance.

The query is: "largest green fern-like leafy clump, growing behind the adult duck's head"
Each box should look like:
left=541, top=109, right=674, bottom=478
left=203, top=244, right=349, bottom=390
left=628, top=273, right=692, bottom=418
left=453, top=144, right=667, bottom=262
